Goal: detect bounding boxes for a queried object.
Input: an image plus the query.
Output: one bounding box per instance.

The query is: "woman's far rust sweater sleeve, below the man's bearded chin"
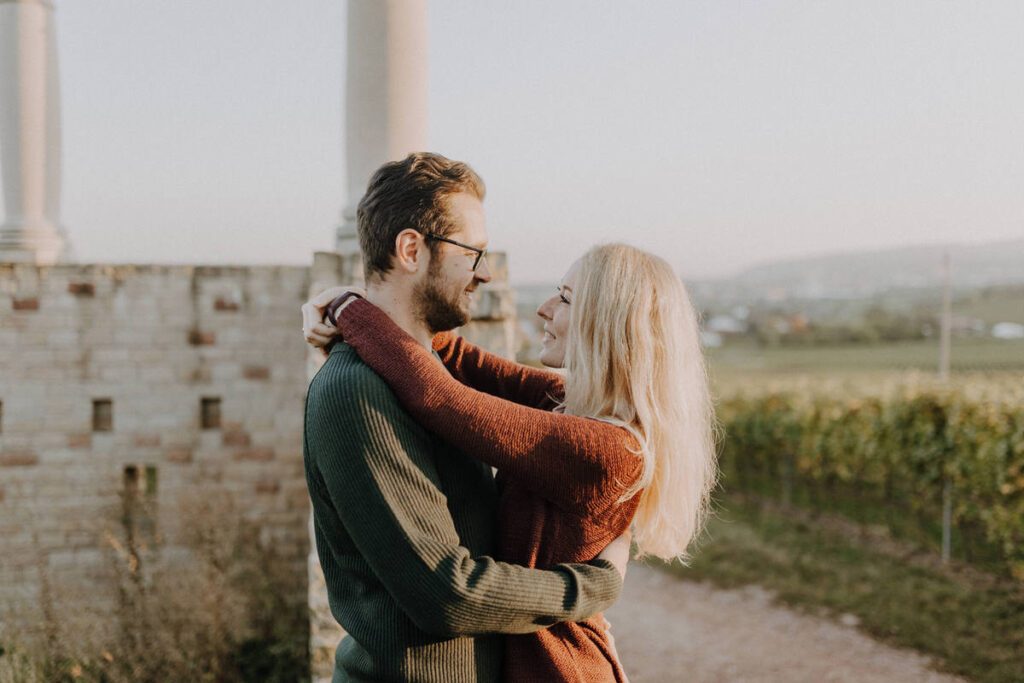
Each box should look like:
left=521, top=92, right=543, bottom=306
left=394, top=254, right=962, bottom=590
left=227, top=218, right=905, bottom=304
left=433, top=332, right=565, bottom=408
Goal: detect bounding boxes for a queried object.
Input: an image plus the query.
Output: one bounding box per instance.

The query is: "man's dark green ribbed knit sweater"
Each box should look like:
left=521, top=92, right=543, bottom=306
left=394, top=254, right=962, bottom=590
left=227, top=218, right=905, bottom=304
left=304, top=343, right=622, bottom=683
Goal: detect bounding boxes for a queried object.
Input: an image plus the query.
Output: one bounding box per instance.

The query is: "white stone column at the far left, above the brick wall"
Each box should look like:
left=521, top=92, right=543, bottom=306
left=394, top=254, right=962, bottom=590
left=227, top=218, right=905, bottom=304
left=0, top=0, right=67, bottom=265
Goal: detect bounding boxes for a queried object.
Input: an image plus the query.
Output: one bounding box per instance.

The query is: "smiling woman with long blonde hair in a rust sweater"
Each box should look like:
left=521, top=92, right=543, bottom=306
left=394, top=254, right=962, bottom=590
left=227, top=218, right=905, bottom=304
left=307, top=245, right=717, bottom=681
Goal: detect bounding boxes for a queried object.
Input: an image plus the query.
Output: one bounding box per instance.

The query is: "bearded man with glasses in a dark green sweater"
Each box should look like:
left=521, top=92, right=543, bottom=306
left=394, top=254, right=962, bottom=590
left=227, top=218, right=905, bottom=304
left=303, top=154, right=628, bottom=682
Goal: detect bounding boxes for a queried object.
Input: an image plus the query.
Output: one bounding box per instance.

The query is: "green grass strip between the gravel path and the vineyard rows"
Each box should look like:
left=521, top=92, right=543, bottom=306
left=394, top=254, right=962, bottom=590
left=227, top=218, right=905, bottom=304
left=667, top=495, right=1024, bottom=683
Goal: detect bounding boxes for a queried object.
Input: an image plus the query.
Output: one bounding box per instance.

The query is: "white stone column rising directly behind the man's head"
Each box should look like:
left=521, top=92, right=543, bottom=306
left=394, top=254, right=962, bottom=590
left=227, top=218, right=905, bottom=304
left=336, top=0, right=428, bottom=254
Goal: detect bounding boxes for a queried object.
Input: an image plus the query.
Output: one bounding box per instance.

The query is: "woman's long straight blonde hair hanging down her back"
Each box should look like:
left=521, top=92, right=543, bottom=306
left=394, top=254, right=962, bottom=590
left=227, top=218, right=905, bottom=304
left=563, top=244, right=718, bottom=562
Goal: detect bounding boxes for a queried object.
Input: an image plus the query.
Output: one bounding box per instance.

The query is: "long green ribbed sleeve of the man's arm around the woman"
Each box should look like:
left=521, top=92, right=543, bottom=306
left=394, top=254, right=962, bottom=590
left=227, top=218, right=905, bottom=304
left=306, top=356, right=622, bottom=637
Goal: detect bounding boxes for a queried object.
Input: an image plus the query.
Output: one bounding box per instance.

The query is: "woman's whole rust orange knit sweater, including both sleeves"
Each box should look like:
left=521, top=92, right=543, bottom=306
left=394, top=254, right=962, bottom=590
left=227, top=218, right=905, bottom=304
left=338, top=299, right=643, bottom=683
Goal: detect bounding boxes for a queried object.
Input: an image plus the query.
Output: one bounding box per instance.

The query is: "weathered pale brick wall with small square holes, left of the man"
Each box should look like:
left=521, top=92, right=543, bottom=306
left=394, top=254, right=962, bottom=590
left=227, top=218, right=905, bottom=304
left=0, top=264, right=309, bottom=630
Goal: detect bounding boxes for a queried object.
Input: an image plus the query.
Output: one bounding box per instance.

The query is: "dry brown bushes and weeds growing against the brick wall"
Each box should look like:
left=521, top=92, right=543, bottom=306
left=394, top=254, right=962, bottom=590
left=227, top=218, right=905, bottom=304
left=0, top=493, right=308, bottom=683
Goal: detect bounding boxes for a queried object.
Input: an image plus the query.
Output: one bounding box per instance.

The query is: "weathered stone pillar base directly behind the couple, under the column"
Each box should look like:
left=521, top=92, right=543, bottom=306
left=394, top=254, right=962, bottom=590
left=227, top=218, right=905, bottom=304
left=308, top=252, right=516, bottom=683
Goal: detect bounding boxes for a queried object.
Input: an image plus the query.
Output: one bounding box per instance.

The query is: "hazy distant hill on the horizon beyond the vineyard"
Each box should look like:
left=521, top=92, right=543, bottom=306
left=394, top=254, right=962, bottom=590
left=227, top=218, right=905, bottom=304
left=692, top=240, right=1024, bottom=301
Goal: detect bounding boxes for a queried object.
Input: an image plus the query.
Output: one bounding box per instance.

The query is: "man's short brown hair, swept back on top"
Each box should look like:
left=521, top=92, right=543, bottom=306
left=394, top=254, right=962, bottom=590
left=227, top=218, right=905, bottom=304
left=355, top=152, right=486, bottom=278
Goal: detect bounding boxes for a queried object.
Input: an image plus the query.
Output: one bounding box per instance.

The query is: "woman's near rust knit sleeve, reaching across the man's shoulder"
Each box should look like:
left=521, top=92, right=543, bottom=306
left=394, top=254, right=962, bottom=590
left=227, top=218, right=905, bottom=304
left=338, top=299, right=643, bottom=513
